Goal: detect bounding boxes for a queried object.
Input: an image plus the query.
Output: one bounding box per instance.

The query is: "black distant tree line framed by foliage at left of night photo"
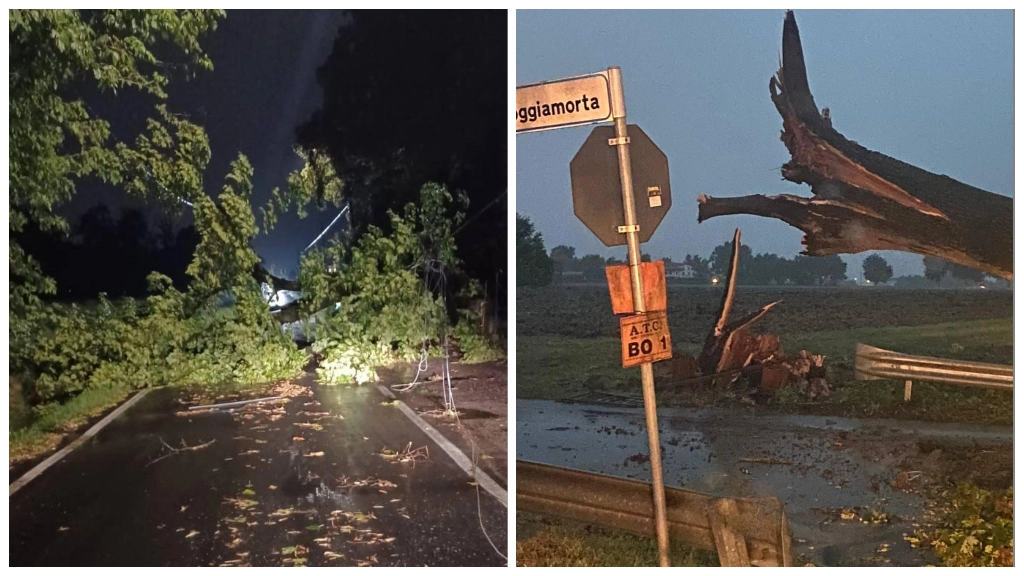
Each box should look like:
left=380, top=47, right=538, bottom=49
left=19, top=204, right=200, bottom=301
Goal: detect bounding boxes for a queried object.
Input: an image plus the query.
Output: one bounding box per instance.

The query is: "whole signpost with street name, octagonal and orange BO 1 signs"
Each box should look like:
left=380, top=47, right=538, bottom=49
left=520, top=67, right=672, bottom=567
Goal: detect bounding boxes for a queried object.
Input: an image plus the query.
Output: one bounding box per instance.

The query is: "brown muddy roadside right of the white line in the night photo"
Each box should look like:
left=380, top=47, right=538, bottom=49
left=377, top=359, right=509, bottom=489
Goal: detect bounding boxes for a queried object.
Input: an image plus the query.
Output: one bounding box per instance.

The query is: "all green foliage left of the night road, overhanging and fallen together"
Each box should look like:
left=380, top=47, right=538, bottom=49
left=9, top=10, right=304, bottom=420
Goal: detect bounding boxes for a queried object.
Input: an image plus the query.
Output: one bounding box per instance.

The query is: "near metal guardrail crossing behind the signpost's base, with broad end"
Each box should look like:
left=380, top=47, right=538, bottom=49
left=516, top=460, right=793, bottom=566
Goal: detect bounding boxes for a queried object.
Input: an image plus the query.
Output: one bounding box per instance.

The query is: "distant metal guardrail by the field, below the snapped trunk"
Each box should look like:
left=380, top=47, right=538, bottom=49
left=855, top=344, right=1014, bottom=401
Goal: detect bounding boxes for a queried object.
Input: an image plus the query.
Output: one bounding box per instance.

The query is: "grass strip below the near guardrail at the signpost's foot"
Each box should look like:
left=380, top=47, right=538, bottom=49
left=515, top=511, right=719, bottom=568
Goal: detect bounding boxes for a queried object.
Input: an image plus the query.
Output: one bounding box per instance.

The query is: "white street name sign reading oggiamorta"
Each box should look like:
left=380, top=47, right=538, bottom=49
left=512, top=72, right=611, bottom=134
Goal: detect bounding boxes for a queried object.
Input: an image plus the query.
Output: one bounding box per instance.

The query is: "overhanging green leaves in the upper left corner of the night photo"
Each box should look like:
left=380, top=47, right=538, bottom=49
left=8, top=10, right=223, bottom=305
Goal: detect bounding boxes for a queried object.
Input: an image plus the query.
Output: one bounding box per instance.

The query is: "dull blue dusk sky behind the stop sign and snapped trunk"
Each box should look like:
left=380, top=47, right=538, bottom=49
left=516, top=10, right=1014, bottom=278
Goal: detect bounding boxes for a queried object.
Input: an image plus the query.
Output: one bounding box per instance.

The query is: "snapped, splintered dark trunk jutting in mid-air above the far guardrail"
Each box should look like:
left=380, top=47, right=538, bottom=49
left=697, top=11, right=1013, bottom=280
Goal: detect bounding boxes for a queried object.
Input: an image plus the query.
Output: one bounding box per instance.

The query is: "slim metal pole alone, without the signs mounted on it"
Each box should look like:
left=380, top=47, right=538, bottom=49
left=608, top=67, right=669, bottom=566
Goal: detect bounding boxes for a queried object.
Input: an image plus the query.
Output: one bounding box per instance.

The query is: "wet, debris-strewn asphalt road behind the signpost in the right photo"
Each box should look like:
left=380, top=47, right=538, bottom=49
left=516, top=400, right=1013, bottom=566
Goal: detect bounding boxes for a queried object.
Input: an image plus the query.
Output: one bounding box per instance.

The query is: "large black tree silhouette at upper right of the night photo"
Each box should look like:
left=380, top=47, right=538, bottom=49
left=298, top=10, right=508, bottom=291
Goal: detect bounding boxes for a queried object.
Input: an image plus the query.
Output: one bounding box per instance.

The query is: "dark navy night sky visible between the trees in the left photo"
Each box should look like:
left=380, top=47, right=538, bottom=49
left=67, top=10, right=352, bottom=271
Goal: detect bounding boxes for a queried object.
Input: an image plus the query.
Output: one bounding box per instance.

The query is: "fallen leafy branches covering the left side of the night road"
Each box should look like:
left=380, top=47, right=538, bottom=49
left=12, top=156, right=305, bottom=403
